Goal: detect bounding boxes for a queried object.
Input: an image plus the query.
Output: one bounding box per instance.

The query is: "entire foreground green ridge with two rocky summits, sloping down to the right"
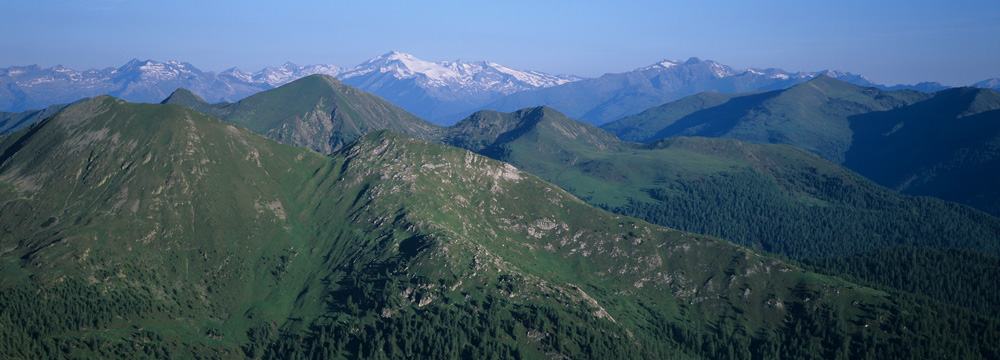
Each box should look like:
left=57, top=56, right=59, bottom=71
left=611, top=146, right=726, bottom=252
left=0, top=97, right=1000, bottom=358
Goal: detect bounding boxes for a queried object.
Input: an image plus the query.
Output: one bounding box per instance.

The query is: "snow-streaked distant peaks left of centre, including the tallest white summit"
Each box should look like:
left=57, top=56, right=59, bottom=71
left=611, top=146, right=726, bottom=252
left=0, top=52, right=581, bottom=122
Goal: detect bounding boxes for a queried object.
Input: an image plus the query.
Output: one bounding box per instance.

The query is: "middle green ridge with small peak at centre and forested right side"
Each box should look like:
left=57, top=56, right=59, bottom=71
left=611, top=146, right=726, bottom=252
left=446, top=108, right=1000, bottom=258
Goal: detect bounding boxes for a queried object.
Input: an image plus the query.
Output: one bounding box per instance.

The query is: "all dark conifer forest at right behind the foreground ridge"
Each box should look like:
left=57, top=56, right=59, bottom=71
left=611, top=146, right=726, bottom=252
left=609, top=172, right=1000, bottom=316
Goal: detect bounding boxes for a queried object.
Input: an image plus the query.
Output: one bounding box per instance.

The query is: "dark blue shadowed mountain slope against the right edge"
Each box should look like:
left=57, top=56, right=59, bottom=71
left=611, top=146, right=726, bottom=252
left=844, top=88, right=1000, bottom=214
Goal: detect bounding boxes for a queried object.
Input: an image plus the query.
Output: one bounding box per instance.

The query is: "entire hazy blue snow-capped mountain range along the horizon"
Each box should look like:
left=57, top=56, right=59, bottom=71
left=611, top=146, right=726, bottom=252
left=0, top=52, right=1000, bottom=125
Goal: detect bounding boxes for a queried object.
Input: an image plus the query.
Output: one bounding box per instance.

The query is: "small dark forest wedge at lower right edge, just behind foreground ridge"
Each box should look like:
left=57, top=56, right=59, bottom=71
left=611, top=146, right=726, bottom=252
left=804, top=246, right=1000, bottom=317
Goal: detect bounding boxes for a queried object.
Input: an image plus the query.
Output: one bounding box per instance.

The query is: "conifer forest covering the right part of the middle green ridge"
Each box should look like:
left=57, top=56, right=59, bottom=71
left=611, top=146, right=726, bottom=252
left=601, top=171, right=1000, bottom=259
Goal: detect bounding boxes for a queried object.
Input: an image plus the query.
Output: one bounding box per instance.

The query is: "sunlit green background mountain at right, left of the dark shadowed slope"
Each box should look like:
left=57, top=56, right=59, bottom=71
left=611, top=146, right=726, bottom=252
left=603, top=75, right=931, bottom=163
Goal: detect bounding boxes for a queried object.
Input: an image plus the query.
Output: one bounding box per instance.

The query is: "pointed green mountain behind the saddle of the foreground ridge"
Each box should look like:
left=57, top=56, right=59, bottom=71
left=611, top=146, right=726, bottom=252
left=165, top=75, right=440, bottom=154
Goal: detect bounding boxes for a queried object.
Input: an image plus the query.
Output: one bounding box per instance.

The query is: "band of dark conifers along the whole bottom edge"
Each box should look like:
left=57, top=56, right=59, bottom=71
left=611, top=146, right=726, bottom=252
left=0, top=276, right=1000, bottom=359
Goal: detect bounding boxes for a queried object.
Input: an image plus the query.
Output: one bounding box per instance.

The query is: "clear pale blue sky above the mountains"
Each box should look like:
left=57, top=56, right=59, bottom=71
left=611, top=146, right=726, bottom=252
left=0, top=0, right=1000, bottom=85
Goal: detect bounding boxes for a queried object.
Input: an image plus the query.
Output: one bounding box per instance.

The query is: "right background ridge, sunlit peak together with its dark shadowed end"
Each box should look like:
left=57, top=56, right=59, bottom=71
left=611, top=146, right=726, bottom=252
left=602, top=76, right=1000, bottom=215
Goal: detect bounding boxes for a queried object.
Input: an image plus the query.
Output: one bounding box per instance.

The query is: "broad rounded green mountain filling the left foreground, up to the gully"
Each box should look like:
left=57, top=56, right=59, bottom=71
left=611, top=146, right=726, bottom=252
left=0, top=97, right=340, bottom=357
